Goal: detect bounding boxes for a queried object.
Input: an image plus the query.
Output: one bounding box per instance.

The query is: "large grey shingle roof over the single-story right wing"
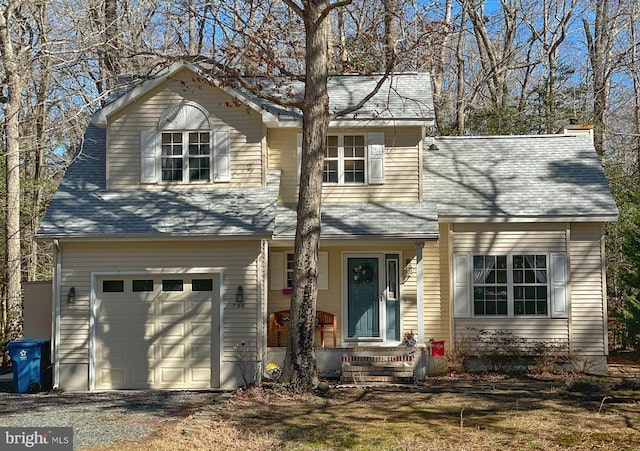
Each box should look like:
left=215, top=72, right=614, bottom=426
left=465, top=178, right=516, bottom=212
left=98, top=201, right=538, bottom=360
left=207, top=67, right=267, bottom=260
left=424, top=135, right=618, bottom=221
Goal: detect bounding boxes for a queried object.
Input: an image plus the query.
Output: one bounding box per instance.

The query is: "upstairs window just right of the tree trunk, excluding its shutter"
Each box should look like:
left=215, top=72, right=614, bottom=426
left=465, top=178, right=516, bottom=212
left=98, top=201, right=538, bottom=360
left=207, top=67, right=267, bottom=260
left=322, top=135, right=367, bottom=184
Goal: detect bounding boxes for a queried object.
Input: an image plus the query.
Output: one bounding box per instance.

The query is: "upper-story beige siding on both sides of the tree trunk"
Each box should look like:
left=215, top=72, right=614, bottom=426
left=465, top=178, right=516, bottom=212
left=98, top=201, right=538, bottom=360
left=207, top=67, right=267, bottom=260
left=268, top=127, right=422, bottom=203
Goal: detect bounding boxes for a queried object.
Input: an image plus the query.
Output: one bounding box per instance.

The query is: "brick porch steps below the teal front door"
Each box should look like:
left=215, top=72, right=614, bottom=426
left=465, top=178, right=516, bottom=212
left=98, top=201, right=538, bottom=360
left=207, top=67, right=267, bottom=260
left=340, top=350, right=415, bottom=384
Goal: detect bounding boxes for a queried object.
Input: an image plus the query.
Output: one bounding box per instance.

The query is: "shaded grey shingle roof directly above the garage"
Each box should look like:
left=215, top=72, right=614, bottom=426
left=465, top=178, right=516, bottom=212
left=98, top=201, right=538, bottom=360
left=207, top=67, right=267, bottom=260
left=38, top=126, right=280, bottom=238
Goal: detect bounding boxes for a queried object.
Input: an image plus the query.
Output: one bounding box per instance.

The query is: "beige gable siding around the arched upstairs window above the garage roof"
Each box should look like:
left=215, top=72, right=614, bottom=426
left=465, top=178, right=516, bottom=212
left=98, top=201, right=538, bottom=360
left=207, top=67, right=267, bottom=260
left=107, top=70, right=266, bottom=189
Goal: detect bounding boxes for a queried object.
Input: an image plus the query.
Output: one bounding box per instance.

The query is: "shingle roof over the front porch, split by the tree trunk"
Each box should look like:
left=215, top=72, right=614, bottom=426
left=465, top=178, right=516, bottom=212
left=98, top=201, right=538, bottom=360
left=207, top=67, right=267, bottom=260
left=275, top=202, right=438, bottom=240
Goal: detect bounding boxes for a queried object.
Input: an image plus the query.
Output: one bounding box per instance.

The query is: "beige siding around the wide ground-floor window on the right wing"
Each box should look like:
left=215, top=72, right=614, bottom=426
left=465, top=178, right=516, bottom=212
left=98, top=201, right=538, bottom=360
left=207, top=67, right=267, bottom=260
left=448, top=223, right=607, bottom=355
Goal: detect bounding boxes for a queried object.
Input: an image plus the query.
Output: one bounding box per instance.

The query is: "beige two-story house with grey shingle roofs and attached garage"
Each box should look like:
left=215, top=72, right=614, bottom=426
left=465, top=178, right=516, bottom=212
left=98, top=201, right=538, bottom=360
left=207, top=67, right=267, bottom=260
left=38, top=64, right=617, bottom=391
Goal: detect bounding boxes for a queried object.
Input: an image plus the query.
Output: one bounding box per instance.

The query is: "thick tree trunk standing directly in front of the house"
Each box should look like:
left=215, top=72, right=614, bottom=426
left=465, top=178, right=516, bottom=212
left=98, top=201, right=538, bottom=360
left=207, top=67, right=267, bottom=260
left=283, top=0, right=329, bottom=393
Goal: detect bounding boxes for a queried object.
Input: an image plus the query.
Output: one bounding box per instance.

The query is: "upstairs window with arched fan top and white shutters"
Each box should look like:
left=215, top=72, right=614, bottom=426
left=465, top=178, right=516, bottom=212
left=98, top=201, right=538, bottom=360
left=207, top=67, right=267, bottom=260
left=141, top=102, right=231, bottom=183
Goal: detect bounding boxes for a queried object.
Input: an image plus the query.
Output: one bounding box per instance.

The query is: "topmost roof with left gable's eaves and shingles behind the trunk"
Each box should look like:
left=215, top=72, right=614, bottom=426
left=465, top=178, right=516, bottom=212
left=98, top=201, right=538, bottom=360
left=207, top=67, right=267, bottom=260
left=92, top=63, right=435, bottom=127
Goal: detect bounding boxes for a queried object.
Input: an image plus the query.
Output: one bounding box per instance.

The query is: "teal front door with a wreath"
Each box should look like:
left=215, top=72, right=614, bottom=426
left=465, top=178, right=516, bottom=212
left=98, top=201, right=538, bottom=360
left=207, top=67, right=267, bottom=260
left=347, top=257, right=381, bottom=338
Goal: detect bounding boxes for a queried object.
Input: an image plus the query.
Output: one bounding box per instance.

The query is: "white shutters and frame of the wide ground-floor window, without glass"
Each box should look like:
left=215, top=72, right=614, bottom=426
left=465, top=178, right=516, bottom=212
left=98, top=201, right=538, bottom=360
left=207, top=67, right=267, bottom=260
left=453, top=251, right=568, bottom=319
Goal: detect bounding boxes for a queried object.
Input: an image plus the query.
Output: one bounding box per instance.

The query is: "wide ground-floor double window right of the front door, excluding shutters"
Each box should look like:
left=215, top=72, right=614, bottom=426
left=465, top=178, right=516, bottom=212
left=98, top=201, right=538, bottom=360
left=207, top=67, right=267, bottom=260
left=473, top=254, right=549, bottom=316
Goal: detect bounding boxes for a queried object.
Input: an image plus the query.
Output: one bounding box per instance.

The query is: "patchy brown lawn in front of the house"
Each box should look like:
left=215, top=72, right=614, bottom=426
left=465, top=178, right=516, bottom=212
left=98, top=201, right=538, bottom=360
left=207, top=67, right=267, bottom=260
left=91, top=376, right=640, bottom=450
